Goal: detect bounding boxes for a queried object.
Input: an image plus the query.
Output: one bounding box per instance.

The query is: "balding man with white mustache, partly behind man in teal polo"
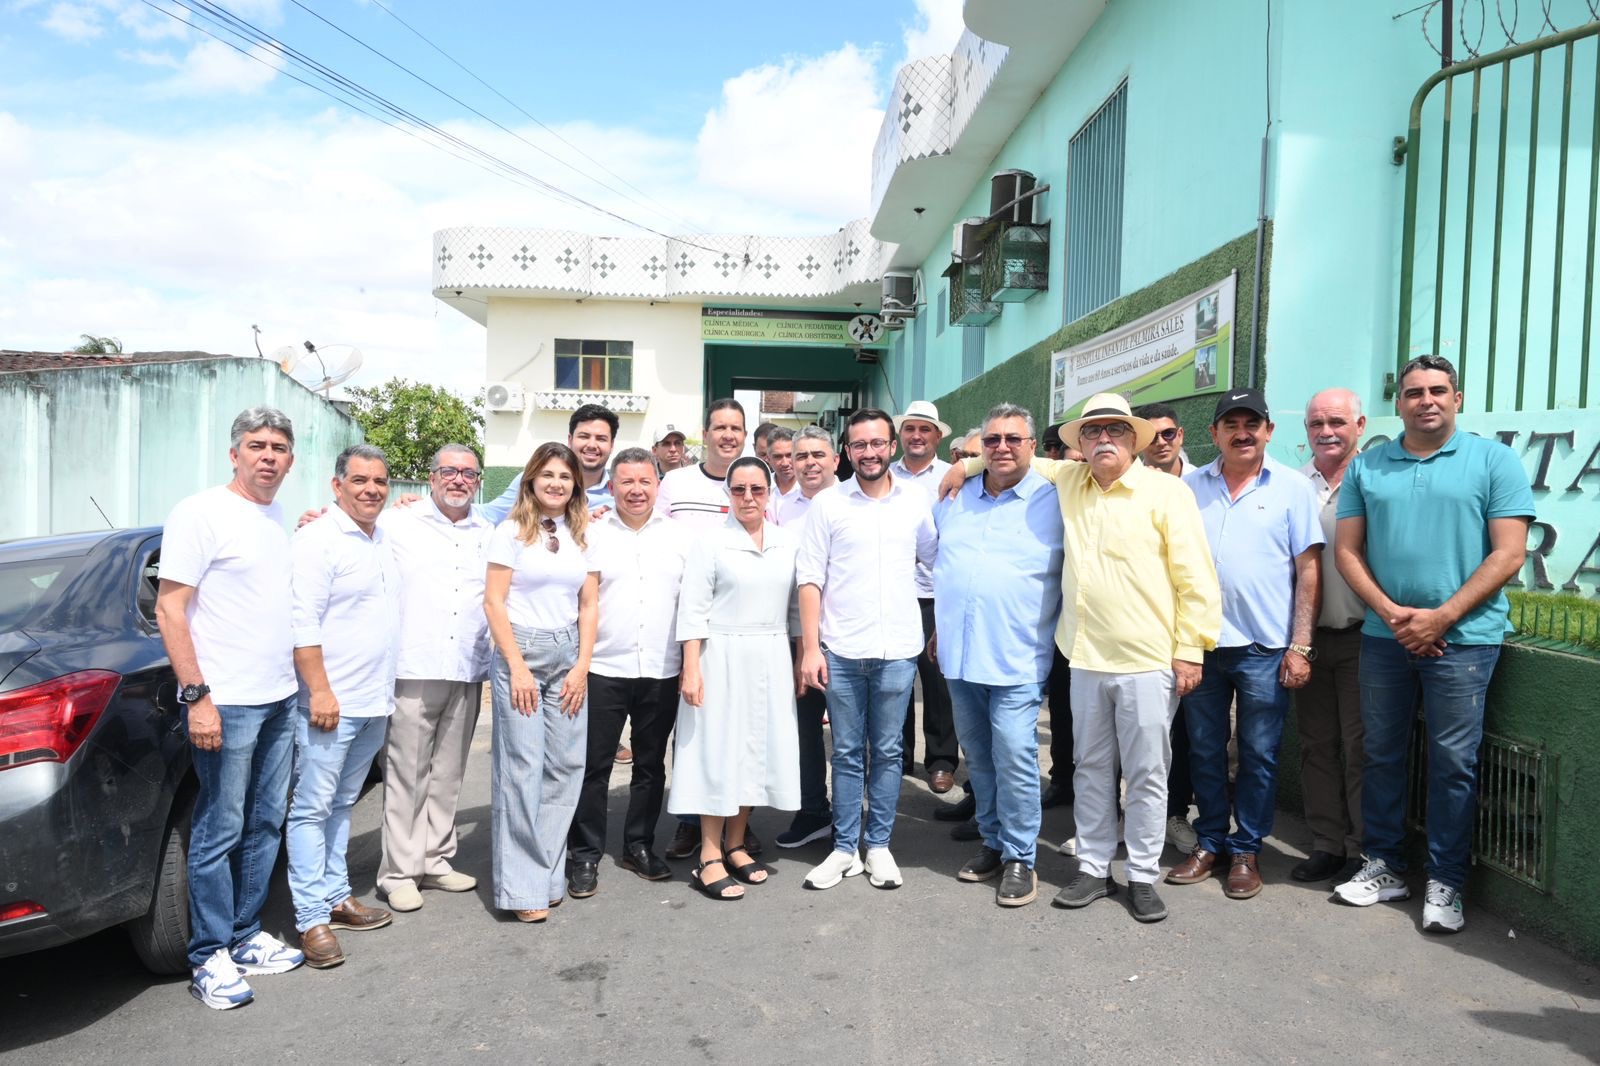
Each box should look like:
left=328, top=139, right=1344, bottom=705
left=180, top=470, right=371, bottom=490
left=1290, top=389, right=1366, bottom=880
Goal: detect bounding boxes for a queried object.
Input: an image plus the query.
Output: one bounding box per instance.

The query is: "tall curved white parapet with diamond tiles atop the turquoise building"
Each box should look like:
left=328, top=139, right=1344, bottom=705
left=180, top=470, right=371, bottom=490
left=872, top=30, right=1010, bottom=214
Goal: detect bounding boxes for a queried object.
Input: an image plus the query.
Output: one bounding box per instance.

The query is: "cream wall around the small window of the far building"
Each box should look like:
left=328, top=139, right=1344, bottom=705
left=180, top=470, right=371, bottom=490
left=483, top=296, right=704, bottom=467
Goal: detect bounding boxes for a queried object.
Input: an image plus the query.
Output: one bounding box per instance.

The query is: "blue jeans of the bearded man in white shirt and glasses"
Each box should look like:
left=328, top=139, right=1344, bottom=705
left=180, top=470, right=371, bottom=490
left=822, top=648, right=917, bottom=852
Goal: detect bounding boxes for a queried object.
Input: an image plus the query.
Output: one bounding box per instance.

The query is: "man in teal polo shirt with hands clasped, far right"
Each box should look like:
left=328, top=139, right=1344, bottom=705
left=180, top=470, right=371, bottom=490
left=1334, top=355, right=1534, bottom=933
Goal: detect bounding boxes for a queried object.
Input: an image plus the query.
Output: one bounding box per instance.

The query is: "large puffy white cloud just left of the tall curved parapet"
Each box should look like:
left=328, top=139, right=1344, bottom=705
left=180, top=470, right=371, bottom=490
left=696, top=45, right=883, bottom=224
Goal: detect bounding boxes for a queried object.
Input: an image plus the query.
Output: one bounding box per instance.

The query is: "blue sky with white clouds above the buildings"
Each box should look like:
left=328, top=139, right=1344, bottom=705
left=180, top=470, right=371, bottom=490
left=0, top=0, right=962, bottom=389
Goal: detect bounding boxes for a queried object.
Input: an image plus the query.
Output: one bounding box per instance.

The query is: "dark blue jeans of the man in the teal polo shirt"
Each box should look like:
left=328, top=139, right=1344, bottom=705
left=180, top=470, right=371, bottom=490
left=1362, top=635, right=1499, bottom=888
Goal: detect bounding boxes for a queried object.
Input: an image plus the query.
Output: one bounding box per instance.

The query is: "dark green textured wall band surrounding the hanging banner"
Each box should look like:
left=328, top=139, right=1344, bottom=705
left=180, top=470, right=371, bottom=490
left=936, top=226, right=1272, bottom=451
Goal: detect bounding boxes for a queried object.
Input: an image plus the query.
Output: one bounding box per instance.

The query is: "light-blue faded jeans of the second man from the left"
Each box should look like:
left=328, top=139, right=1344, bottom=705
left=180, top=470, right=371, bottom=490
left=288, top=707, right=389, bottom=933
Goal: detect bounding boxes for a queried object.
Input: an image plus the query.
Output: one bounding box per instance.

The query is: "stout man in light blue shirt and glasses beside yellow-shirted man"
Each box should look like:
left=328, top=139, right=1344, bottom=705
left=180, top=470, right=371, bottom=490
left=930, top=403, right=1064, bottom=908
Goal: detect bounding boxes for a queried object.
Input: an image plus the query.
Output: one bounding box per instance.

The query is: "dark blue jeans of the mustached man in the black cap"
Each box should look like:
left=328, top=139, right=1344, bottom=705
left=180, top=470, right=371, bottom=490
left=1182, top=643, right=1290, bottom=855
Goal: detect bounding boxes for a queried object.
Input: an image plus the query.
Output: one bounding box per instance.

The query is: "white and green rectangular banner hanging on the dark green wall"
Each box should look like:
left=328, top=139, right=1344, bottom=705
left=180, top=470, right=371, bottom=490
left=1050, top=274, right=1238, bottom=424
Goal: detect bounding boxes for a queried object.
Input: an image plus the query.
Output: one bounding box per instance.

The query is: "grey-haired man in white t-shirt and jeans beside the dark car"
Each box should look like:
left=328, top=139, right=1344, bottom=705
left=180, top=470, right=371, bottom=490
left=155, top=407, right=304, bottom=1010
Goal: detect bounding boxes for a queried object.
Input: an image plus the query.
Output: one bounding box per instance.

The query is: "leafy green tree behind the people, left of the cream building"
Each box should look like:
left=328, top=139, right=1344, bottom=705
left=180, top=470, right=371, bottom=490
left=349, top=378, right=483, bottom=480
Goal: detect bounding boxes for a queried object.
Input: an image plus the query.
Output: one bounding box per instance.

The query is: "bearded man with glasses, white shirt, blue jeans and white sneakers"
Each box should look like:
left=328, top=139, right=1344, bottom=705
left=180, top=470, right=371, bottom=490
left=795, top=408, right=939, bottom=888
